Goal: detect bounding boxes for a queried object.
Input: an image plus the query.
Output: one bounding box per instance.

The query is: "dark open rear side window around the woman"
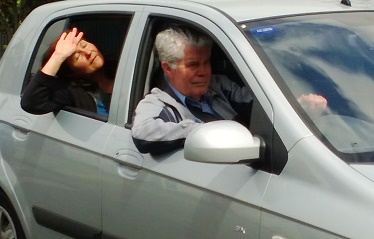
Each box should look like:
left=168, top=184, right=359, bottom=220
left=23, top=13, right=131, bottom=121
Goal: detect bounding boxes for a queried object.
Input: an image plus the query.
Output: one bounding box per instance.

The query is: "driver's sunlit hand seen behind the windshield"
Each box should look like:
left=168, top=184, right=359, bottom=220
left=297, top=94, right=327, bottom=119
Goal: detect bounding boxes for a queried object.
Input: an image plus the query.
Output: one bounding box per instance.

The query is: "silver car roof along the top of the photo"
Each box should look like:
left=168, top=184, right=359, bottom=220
left=64, top=0, right=374, bottom=22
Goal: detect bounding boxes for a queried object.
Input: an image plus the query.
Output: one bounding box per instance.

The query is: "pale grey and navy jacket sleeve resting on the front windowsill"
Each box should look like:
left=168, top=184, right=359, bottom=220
left=131, top=91, right=200, bottom=154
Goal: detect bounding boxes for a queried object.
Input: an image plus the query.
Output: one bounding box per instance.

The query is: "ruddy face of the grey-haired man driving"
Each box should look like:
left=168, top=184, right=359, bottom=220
left=162, top=46, right=212, bottom=100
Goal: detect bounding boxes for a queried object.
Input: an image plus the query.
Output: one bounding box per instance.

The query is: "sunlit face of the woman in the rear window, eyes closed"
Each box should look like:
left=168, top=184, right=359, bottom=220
left=67, top=39, right=104, bottom=74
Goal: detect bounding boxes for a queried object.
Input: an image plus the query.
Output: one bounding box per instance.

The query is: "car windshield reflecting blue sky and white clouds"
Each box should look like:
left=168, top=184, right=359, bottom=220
left=241, top=12, right=374, bottom=162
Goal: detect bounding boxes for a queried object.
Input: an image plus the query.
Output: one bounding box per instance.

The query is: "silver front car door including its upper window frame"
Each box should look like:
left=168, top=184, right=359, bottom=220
left=102, top=7, right=280, bottom=239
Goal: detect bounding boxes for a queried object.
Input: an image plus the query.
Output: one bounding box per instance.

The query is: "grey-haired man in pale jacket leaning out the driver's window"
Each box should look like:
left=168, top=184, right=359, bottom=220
left=132, top=25, right=328, bottom=154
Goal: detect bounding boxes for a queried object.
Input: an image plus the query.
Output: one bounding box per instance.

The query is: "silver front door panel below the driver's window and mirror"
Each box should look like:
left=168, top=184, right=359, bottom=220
left=102, top=127, right=268, bottom=239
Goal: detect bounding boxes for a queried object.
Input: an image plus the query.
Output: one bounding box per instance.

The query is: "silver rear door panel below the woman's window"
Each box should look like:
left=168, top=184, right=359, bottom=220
left=1, top=111, right=113, bottom=238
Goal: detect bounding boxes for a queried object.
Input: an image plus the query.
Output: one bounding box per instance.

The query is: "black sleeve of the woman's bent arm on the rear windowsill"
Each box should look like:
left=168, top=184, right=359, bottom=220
left=21, top=71, right=73, bottom=114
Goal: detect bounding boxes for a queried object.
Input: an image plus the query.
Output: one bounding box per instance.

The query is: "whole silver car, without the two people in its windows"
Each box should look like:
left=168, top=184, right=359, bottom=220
left=0, top=0, right=374, bottom=239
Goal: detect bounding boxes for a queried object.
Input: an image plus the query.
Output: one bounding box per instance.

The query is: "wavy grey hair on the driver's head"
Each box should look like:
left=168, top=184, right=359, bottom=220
left=155, top=27, right=212, bottom=67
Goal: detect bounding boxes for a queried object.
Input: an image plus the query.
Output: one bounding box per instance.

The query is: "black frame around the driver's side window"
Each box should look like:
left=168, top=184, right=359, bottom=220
left=125, top=11, right=288, bottom=174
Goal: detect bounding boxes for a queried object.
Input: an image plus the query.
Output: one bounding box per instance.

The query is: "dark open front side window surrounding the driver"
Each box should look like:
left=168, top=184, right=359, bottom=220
left=127, top=17, right=287, bottom=173
